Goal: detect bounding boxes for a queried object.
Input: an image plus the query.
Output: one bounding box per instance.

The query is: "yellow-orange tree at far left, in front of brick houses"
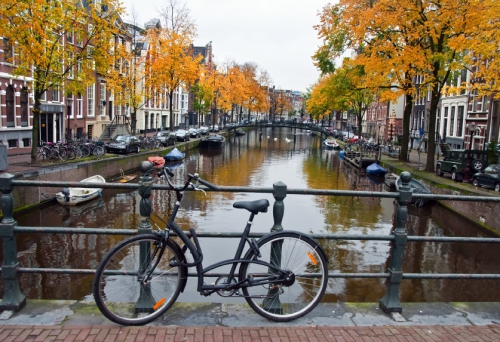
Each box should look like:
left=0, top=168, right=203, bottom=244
left=0, top=0, right=123, bottom=162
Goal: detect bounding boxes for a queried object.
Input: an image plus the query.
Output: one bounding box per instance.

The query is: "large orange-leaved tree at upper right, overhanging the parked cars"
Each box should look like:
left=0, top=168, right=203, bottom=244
left=315, top=0, right=500, bottom=171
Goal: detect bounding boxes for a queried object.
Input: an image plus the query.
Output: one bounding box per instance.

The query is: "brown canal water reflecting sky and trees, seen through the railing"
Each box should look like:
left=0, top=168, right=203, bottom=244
left=0, top=128, right=500, bottom=302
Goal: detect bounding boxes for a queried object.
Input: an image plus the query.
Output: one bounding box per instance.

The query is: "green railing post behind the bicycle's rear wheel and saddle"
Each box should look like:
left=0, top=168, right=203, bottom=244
left=262, top=182, right=286, bottom=314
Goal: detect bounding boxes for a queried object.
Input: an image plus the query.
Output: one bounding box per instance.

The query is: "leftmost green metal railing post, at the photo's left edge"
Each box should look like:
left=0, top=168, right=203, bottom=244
left=0, top=173, right=26, bottom=311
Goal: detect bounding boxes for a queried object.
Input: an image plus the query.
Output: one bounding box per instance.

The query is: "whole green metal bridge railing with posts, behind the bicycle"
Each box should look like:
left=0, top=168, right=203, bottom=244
left=0, top=169, right=500, bottom=313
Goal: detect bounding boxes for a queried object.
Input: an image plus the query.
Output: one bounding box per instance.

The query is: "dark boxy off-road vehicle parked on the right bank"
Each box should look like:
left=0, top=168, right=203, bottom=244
left=436, top=150, right=488, bottom=181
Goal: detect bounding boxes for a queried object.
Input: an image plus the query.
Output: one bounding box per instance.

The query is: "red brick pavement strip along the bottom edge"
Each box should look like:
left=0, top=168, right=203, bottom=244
left=0, top=325, right=500, bottom=342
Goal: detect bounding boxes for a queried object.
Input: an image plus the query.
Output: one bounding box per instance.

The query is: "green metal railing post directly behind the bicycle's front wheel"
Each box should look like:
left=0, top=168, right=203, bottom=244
left=135, top=161, right=153, bottom=313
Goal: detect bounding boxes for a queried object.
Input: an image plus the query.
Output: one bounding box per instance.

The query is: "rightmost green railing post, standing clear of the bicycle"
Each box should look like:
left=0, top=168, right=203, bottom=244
left=379, top=171, right=412, bottom=313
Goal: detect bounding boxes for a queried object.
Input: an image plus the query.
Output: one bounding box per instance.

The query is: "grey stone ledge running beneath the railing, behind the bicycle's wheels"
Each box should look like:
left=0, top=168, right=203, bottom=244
left=0, top=299, right=500, bottom=327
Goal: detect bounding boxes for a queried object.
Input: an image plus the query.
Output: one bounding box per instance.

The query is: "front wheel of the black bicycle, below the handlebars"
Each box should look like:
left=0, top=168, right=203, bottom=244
left=93, top=234, right=187, bottom=325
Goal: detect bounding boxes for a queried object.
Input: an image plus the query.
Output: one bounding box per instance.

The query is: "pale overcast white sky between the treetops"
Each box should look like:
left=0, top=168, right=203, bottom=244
left=124, top=0, right=330, bottom=91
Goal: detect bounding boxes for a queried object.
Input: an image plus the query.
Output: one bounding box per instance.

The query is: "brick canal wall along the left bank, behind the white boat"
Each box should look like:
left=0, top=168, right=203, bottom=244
left=0, top=139, right=200, bottom=217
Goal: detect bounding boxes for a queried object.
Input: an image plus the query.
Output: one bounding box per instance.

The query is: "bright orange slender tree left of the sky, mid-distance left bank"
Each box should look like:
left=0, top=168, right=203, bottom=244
left=145, top=28, right=203, bottom=129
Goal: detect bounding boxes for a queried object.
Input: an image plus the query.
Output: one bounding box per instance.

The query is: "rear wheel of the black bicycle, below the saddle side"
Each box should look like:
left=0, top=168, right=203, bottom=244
left=239, top=232, right=328, bottom=322
